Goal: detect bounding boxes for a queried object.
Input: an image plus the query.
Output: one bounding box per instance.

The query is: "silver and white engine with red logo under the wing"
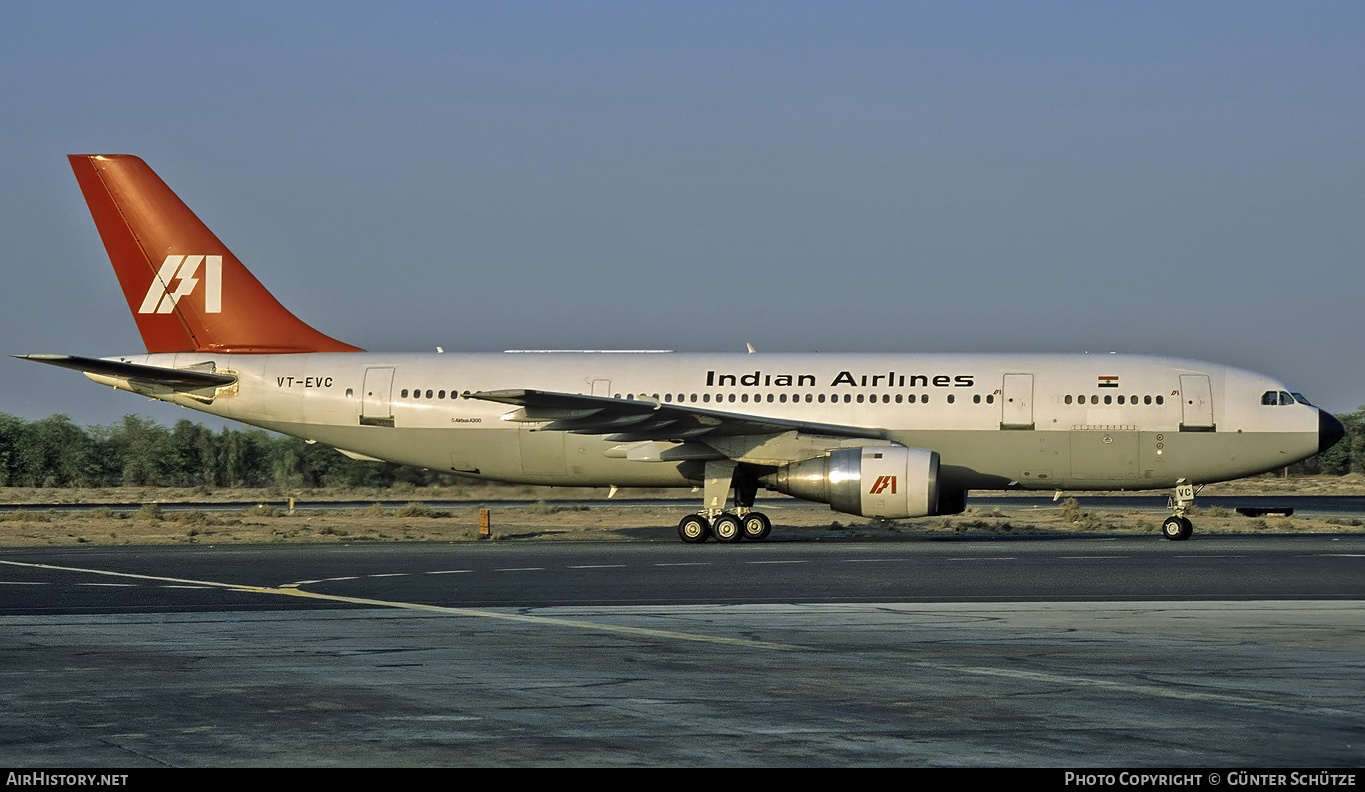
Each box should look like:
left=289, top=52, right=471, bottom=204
left=762, top=445, right=939, bottom=519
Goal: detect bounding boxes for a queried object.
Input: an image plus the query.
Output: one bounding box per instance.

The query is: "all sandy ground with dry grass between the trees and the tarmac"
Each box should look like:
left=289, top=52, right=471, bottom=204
left=0, top=475, right=1365, bottom=546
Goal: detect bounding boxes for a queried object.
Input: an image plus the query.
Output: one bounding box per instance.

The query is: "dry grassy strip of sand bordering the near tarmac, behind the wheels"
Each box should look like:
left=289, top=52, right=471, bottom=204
left=0, top=490, right=1365, bottom=546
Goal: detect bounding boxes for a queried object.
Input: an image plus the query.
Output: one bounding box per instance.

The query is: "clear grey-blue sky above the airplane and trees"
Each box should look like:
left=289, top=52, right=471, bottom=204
left=0, top=0, right=1365, bottom=425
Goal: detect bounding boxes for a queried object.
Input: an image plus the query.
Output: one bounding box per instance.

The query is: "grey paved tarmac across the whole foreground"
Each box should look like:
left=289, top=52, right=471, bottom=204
left=0, top=535, right=1365, bottom=769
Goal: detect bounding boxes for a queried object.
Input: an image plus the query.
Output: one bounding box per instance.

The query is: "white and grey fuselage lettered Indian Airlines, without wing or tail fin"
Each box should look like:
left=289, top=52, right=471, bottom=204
left=89, top=352, right=1319, bottom=490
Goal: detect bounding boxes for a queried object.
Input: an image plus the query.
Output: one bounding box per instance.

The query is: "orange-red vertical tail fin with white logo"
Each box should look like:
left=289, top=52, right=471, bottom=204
left=68, top=154, right=362, bottom=354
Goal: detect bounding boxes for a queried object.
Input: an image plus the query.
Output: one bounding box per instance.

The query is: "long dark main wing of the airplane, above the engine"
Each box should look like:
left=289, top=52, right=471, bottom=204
left=470, top=389, right=886, bottom=456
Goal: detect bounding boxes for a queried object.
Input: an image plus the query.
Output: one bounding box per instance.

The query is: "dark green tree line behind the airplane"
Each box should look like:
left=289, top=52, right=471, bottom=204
left=0, top=407, right=1365, bottom=489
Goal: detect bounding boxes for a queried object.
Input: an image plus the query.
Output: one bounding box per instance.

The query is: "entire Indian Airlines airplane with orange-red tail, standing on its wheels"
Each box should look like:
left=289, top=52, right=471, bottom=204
left=16, top=154, right=1345, bottom=542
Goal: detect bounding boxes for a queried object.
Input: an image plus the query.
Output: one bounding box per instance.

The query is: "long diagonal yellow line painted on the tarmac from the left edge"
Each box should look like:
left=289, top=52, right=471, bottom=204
left=0, top=561, right=804, bottom=651
